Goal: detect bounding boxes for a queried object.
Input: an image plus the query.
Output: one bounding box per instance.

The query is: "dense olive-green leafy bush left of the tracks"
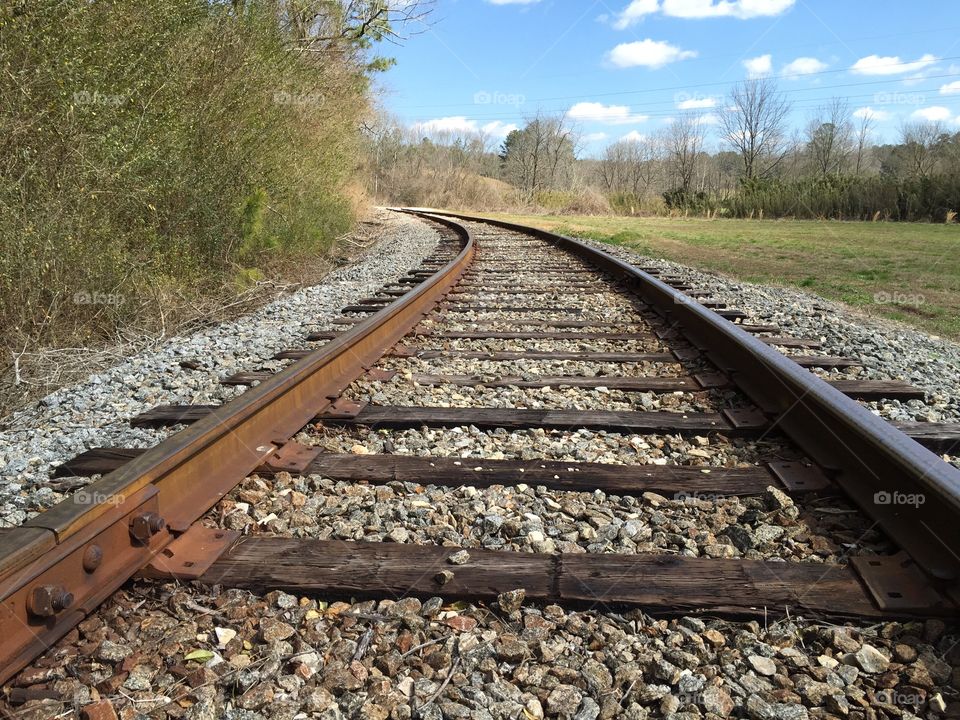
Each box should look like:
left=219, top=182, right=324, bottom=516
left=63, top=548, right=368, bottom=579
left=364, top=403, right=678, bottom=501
left=0, top=0, right=367, bottom=366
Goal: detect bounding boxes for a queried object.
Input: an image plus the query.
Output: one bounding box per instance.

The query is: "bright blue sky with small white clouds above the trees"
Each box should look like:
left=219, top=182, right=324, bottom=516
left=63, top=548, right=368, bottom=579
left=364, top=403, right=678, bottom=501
left=381, top=0, right=960, bottom=155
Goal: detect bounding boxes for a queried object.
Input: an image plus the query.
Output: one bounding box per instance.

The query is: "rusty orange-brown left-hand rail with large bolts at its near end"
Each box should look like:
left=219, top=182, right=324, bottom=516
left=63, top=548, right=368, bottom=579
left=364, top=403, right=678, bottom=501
left=0, top=218, right=475, bottom=683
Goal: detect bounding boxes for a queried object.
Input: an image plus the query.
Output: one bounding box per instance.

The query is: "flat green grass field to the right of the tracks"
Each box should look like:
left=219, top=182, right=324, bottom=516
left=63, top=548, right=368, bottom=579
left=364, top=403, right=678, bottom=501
left=495, top=215, right=960, bottom=339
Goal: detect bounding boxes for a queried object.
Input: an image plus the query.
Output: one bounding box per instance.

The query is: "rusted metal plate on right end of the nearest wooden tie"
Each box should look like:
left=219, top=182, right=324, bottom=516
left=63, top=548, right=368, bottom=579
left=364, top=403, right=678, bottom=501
left=850, top=553, right=952, bottom=614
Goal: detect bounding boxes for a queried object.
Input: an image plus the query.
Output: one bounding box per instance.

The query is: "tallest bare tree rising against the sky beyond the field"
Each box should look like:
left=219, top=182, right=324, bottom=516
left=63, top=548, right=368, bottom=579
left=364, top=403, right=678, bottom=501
left=720, top=78, right=790, bottom=179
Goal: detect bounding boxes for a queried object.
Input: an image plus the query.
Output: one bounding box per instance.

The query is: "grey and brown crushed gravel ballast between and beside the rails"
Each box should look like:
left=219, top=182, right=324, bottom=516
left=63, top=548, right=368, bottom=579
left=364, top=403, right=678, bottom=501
left=0, top=218, right=960, bottom=720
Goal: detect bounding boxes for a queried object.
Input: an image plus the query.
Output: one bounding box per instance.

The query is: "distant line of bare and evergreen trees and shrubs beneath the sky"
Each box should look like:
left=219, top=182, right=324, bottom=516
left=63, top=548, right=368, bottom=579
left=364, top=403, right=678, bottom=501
left=368, top=78, right=960, bottom=222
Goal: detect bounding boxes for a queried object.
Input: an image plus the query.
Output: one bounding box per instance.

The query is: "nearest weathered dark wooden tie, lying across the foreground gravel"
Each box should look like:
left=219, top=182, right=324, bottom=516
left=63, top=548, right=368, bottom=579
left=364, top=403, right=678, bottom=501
left=182, top=536, right=952, bottom=618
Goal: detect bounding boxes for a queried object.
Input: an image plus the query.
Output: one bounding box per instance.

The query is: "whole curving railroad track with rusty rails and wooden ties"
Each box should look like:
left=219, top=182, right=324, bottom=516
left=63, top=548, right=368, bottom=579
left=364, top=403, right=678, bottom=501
left=0, top=213, right=960, bottom=716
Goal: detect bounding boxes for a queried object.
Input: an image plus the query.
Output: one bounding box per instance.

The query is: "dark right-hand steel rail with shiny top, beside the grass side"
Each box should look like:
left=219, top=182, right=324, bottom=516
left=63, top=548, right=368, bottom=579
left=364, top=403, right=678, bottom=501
left=405, top=208, right=960, bottom=602
